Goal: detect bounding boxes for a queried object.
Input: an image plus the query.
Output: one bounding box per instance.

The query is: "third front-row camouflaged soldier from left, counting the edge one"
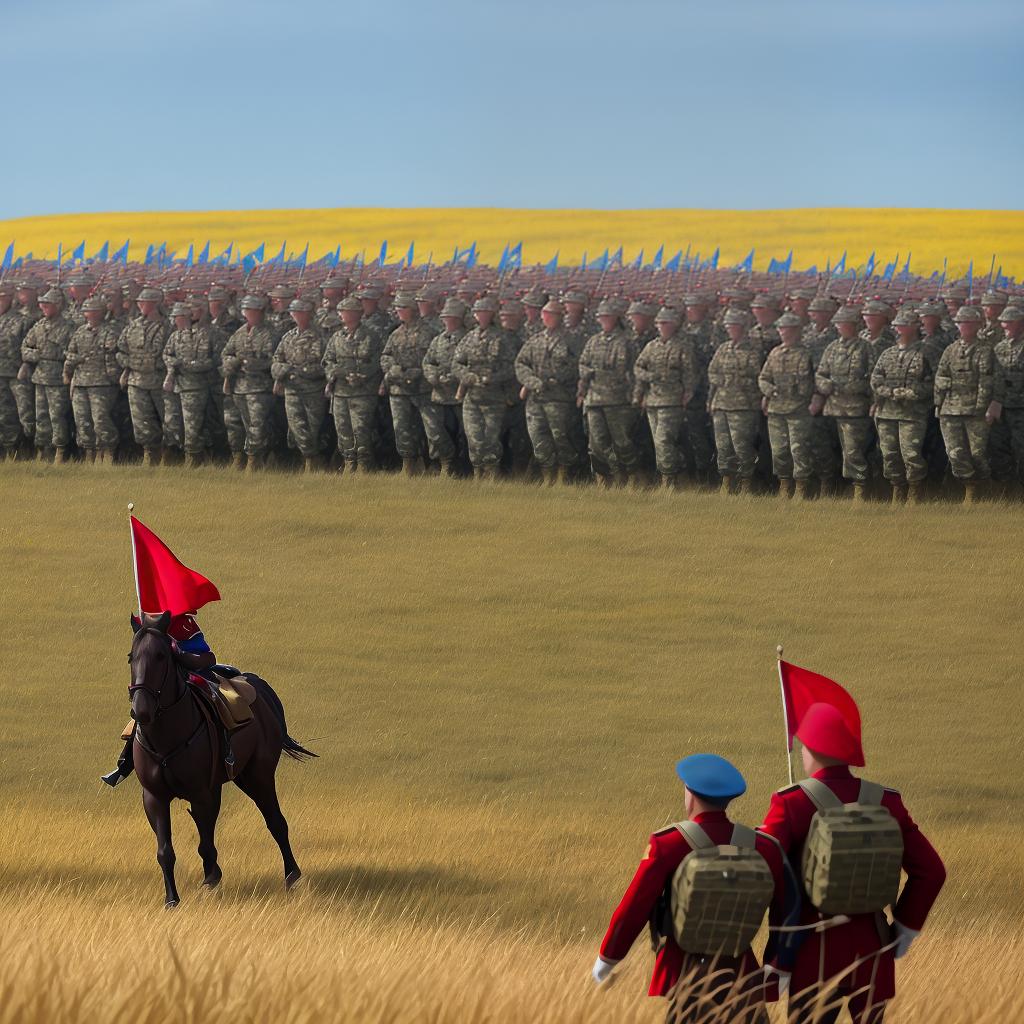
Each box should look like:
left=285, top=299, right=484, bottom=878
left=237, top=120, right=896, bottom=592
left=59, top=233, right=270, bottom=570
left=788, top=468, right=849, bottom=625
left=63, top=295, right=121, bottom=465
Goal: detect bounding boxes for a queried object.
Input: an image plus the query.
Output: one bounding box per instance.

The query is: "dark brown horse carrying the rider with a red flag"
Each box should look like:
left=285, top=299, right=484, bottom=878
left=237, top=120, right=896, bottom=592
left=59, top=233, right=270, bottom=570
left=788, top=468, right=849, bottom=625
left=128, top=612, right=316, bottom=907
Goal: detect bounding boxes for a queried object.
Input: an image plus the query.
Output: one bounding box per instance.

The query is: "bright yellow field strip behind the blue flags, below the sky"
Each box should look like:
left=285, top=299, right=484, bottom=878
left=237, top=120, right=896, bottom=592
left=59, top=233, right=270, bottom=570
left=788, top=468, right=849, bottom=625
left=0, top=208, right=1024, bottom=279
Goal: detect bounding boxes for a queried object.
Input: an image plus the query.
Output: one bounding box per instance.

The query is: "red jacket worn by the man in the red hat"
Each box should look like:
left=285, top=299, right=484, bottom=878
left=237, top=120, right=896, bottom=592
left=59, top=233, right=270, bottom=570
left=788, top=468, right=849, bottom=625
left=761, top=765, right=946, bottom=1001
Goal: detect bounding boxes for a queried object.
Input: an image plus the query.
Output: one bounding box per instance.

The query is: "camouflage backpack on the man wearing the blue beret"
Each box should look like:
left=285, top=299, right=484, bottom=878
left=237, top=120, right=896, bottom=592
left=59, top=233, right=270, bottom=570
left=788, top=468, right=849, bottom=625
left=671, top=821, right=775, bottom=956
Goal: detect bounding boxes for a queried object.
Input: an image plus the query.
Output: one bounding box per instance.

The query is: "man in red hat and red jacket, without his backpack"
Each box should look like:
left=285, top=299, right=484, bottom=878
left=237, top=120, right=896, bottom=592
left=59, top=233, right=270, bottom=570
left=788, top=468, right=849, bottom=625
left=761, top=703, right=946, bottom=1024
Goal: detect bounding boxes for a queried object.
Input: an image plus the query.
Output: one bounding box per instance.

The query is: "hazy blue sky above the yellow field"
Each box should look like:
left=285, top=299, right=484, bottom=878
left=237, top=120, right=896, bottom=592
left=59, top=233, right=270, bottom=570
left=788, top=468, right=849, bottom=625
left=0, top=0, right=1024, bottom=218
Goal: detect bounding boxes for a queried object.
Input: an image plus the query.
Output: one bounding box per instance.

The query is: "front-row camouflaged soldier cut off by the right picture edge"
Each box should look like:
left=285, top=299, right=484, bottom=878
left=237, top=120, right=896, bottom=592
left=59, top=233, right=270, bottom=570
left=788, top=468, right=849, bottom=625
left=987, top=305, right=1024, bottom=497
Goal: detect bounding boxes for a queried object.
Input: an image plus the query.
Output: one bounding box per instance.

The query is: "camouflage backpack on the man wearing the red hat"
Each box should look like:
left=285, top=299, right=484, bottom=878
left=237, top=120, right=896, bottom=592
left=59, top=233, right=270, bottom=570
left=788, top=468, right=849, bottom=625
left=800, top=778, right=903, bottom=913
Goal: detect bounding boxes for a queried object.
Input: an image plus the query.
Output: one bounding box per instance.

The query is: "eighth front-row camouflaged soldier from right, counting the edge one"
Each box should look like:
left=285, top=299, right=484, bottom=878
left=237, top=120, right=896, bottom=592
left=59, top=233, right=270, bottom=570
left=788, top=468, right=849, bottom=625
left=577, top=299, right=639, bottom=485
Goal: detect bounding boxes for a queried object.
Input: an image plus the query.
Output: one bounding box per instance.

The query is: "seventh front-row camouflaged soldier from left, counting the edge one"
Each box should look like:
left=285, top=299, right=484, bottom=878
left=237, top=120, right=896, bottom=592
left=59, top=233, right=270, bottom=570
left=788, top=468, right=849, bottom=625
left=270, top=299, right=327, bottom=473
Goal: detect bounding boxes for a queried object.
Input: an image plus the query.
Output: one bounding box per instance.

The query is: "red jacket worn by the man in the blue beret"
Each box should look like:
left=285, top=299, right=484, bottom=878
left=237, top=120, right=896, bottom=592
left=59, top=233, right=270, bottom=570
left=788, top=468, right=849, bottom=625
left=601, top=811, right=796, bottom=995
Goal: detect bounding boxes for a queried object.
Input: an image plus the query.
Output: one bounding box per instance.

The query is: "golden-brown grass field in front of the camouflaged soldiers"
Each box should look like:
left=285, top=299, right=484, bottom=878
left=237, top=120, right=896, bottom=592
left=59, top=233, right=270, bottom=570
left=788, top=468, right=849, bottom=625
left=0, top=464, right=1024, bottom=1024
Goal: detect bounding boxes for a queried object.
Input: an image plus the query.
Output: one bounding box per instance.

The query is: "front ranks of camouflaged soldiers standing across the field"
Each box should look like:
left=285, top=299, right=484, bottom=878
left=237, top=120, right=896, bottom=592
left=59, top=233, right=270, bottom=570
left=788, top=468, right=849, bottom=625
left=0, top=275, right=1024, bottom=501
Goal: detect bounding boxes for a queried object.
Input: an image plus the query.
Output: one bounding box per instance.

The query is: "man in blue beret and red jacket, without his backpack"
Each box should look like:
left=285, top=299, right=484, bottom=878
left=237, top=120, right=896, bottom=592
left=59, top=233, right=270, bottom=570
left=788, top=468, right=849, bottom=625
left=593, top=754, right=800, bottom=1024
